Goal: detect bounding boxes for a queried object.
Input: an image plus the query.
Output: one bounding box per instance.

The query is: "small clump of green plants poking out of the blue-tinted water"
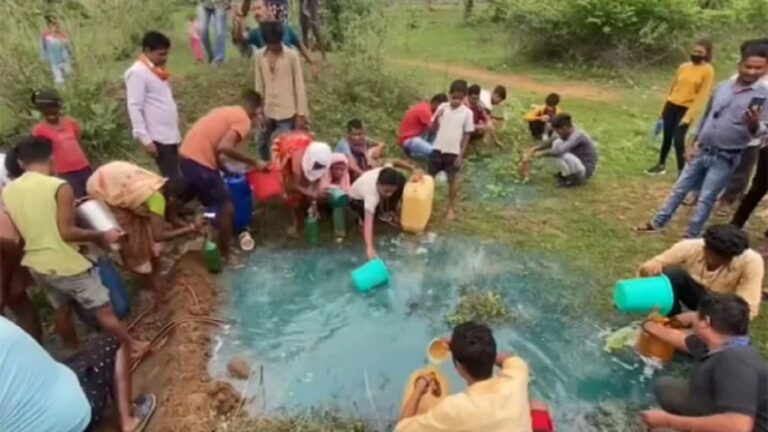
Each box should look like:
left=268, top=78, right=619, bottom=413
left=445, top=290, right=516, bottom=327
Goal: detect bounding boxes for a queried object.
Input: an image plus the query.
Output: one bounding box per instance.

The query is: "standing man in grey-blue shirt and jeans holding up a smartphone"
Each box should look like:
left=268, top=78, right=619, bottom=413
left=637, top=45, right=768, bottom=238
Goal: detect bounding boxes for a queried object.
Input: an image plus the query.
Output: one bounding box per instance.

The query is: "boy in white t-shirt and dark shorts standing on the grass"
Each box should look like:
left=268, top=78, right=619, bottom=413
left=429, top=80, right=475, bottom=220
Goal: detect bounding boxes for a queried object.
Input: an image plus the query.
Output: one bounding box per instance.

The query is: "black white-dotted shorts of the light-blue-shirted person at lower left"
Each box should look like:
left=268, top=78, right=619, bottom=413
left=64, top=334, right=120, bottom=427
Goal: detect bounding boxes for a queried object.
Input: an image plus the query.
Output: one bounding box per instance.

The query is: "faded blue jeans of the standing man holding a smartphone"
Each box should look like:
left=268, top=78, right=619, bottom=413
left=652, top=147, right=741, bottom=238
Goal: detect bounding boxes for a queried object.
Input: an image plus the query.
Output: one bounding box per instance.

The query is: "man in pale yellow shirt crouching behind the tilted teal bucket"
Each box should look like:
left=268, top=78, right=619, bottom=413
left=638, top=225, right=765, bottom=324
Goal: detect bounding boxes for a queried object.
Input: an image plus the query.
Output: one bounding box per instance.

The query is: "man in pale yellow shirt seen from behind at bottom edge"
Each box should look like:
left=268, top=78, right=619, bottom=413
left=395, top=322, right=554, bottom=432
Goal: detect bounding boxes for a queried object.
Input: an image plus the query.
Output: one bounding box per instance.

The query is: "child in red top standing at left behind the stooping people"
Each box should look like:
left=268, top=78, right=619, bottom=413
left=32, top=90, right=93, bottom=199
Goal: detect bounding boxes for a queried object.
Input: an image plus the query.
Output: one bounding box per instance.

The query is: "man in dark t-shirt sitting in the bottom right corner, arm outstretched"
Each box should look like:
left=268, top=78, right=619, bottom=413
left=641, top=294, right=768, bottom=432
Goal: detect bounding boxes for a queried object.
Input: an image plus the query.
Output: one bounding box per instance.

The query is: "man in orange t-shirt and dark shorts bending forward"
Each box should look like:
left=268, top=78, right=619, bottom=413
left=179, top=90, right=266, bottom=265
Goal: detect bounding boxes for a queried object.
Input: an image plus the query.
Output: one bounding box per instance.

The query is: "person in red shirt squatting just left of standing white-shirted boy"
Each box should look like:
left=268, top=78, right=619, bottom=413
left=397, top=93, right=448, bottom=160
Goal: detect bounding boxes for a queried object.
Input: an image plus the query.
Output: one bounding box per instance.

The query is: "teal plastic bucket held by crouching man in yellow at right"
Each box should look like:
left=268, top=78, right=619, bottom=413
left=613, top=275, right=675, bottom=315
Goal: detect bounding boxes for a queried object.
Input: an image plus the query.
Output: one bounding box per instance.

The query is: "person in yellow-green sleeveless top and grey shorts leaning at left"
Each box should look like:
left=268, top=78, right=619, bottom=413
left=3, top=137, right=147, bottom=364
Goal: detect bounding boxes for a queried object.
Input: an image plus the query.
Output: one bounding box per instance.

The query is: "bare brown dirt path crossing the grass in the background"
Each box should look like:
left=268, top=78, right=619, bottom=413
left=395, top=59, right=621, bottom=102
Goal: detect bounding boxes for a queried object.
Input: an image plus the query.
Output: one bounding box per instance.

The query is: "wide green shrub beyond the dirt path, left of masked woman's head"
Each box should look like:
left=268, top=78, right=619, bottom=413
left=495, top=0, right=702, bottom=64
